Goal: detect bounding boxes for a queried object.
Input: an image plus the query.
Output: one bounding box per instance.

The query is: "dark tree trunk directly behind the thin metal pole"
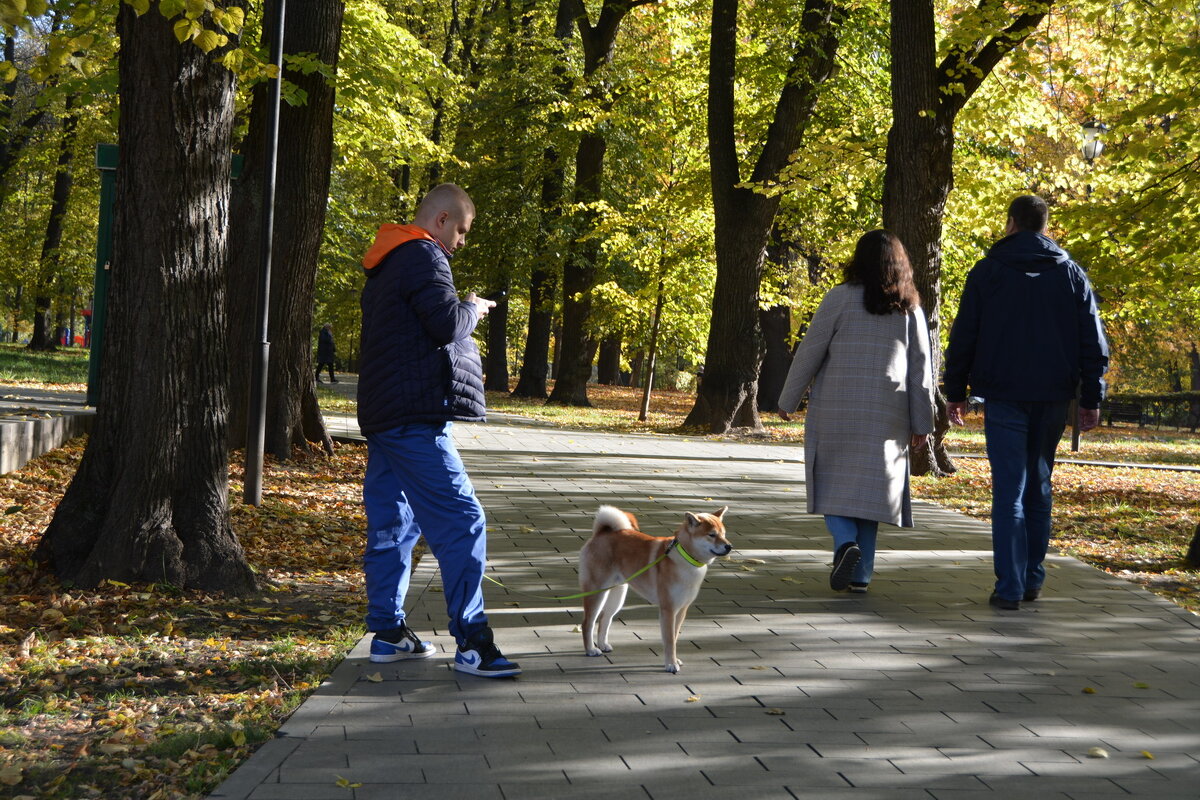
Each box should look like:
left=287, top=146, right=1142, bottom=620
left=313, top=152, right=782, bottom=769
left=227, top=0, right=346, bottom=458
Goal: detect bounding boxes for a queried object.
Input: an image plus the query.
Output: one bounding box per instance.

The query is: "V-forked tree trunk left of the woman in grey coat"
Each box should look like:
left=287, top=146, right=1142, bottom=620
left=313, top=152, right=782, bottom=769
left=684, top=0, right=844, bottom=433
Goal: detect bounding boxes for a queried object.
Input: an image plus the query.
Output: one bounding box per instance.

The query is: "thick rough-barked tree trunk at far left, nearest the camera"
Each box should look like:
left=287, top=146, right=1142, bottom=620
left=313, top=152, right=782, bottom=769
left=36, top=4, right=256, bottom=591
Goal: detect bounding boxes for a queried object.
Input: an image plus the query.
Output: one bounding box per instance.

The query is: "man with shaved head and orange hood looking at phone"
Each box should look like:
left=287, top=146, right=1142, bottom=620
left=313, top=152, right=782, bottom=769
left=359, top=184, right=521, bottom=678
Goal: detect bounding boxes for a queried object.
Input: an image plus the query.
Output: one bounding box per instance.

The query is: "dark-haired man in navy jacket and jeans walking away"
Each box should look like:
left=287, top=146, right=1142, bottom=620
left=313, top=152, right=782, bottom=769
left=944, top=194, right=1109, bottom=610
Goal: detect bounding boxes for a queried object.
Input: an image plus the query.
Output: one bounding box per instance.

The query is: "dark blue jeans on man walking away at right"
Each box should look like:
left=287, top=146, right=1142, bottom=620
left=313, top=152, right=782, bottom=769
left=984, top=401, right=1068, bottom=600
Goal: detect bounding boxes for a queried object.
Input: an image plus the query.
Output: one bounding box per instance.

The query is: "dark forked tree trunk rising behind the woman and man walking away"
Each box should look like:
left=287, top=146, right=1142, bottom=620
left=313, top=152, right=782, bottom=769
left=883, top=0, right=1050, bottom=475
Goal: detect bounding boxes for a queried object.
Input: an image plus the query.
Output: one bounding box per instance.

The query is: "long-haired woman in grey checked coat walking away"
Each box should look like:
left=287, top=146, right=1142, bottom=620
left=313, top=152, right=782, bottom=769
left=779, top=230, right=934, bottom=593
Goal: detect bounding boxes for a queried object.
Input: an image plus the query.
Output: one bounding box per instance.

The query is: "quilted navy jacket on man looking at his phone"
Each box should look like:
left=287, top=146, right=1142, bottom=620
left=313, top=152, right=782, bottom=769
left=359, top=239, right=487, bottom=433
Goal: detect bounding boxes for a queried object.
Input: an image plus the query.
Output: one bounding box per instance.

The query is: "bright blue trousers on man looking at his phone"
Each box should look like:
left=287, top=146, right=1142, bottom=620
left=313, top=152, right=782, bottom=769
left=362, top=422, right=487, bottom=644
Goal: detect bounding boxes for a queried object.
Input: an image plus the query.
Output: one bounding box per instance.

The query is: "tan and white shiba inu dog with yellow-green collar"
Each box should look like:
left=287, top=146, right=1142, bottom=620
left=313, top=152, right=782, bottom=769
left=580, top=506, right=733, bottom=673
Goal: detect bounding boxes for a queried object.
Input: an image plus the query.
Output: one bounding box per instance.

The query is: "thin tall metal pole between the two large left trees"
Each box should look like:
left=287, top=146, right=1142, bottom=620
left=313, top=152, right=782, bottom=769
left=242, top=0, right=288, bottom=506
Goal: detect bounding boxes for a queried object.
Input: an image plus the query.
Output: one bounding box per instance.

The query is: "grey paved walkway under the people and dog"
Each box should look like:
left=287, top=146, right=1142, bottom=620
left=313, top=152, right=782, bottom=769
left=212, top=422, right=1200, bottom=800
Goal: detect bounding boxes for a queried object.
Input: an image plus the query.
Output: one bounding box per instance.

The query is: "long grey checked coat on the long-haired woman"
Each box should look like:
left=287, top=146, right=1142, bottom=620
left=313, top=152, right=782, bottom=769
left=779, top=283, right=934, bottom=528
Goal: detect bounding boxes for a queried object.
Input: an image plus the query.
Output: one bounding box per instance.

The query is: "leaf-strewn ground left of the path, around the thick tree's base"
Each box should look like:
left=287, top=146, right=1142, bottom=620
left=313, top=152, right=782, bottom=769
left=0, top=439, right=366, bottom=800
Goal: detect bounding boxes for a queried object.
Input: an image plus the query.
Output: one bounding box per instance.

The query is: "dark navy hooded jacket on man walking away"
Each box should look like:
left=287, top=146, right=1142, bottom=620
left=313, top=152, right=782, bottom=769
left=944, top=230, right=1109, bottom=408
